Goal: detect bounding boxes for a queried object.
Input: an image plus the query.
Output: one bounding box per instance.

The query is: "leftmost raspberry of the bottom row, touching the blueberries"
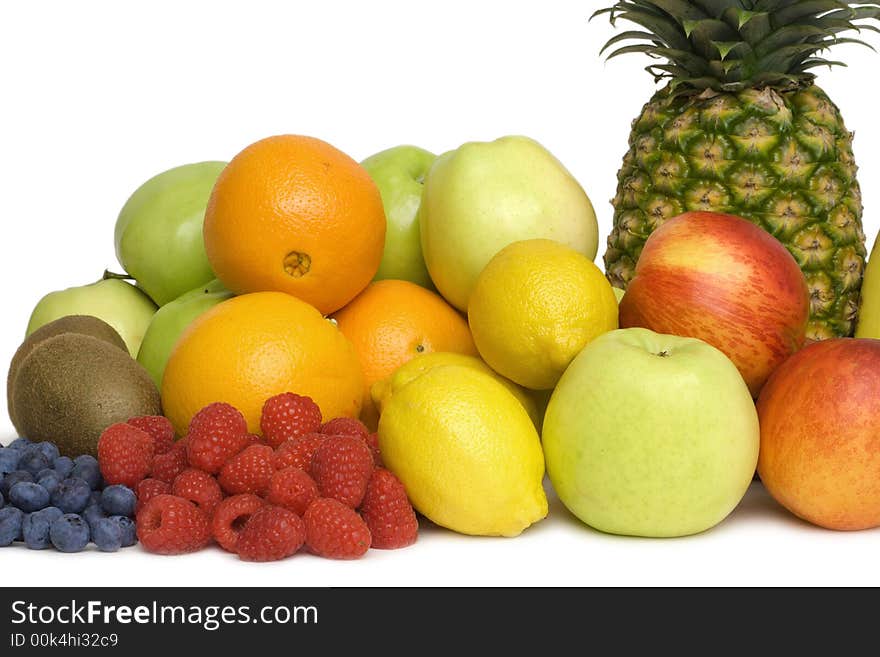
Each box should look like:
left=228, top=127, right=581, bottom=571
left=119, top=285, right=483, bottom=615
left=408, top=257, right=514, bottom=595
left=137, top=495, right=211, bottom=554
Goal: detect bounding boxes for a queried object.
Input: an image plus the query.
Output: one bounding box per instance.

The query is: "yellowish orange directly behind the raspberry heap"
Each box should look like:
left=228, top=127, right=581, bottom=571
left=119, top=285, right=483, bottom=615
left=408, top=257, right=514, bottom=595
left=162, top=292, right=364, bottom=435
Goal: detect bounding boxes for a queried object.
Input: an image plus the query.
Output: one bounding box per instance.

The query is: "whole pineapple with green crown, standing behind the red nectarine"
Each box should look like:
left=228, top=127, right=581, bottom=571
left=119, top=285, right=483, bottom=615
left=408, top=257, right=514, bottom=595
left=594, top=0, right=880, bottom=340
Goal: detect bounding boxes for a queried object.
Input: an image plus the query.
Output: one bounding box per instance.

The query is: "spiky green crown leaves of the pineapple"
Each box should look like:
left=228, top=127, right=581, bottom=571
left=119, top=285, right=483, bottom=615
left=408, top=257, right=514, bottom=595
left=590, top=0, right=880, bottom=95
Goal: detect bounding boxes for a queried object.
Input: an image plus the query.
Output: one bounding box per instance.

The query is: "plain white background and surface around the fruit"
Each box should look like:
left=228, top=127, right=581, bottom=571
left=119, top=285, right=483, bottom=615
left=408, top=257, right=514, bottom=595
left=0, top=0, right=880, bottom=586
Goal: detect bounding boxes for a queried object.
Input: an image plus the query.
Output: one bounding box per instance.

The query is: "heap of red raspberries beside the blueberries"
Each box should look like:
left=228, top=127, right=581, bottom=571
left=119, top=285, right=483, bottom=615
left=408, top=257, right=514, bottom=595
left=98, top=392, right=418, bottom=561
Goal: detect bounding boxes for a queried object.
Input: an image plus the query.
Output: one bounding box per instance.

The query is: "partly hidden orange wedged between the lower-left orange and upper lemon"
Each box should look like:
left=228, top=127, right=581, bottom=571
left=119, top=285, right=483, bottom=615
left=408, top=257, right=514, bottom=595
left=333, top=280, right=477, bottom=427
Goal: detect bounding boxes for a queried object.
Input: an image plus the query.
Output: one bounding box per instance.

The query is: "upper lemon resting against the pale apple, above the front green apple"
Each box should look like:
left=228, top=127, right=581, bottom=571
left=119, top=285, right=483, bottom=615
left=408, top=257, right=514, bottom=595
left=468, top=240, right=617, bottom=390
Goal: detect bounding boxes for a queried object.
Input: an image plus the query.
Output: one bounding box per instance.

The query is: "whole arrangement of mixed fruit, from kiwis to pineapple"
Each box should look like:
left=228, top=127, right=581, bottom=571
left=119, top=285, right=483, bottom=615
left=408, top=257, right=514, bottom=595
left=0, top=0, right=880, bottom=561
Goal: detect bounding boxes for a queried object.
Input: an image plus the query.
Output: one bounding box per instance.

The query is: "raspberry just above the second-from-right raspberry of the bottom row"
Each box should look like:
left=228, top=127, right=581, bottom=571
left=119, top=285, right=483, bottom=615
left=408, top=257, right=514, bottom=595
left=311, top=436, right=373, bottom=509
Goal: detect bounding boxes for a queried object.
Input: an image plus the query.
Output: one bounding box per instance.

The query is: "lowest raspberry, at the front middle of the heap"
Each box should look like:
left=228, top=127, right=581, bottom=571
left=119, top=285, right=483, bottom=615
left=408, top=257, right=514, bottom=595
left=238, top=505, right=306, bottom=561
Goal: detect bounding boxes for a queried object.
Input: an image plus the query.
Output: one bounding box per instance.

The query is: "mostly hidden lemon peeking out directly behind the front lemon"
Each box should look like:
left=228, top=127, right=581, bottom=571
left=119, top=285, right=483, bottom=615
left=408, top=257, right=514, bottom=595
left=370, top=351, right=546, bottom=431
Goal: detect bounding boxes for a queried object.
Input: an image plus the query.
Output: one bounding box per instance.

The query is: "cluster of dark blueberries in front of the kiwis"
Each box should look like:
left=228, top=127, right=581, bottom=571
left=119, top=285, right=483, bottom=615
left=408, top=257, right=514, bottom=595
left=0, top=438, right=137, bottom=552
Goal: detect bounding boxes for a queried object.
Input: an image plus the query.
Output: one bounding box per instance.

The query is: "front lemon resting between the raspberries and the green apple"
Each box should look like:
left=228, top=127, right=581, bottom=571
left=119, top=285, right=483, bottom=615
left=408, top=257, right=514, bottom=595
left=379, top=365, right=547, bottom=536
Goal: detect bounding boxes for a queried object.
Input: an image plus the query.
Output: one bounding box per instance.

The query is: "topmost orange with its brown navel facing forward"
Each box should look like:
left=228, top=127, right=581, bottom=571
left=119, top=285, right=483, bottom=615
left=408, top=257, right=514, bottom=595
left=204, top=135, right=385, bottom=315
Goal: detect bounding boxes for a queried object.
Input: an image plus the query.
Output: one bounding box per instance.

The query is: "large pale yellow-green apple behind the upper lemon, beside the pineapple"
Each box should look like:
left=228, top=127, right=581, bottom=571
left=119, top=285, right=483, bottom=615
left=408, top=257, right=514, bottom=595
left=418, top=136, right=599, bottom=311
